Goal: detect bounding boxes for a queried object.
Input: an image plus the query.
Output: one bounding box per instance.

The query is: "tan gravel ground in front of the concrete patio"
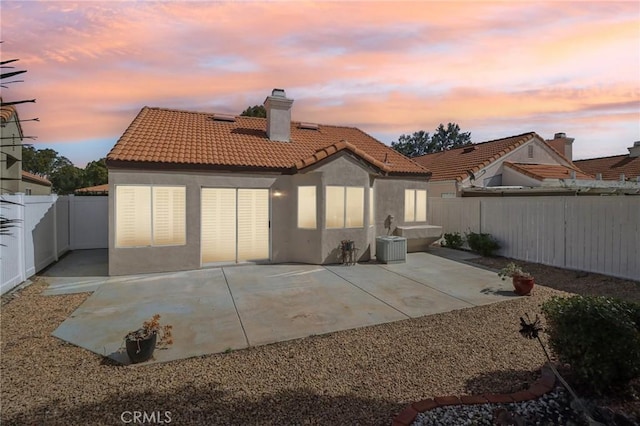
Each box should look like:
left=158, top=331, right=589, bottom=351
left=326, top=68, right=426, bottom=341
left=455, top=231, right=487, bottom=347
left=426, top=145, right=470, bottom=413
left=0, top=258, right=636, bottom=425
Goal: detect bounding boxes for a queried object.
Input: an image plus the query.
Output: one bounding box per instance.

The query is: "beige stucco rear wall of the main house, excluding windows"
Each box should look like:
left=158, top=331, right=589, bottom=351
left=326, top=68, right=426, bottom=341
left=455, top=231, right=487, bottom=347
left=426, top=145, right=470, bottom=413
left=109, top=153, right=427, bottom=275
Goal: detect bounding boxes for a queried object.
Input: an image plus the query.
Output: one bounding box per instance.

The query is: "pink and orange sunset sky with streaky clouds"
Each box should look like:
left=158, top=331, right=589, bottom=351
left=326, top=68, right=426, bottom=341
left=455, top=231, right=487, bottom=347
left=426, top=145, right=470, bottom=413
left=0, top=0, right=640, bottom=167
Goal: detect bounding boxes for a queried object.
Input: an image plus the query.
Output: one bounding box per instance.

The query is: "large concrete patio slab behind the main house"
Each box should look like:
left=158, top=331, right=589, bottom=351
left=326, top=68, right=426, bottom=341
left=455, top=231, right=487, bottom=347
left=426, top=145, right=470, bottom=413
left=43, top=250, right=516, bottom=364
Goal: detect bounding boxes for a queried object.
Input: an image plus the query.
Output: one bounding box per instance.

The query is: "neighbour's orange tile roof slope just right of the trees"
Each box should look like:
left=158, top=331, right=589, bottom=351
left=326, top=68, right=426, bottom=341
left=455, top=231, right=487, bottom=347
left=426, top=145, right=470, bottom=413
left=413, top=132, right=544, bottom=181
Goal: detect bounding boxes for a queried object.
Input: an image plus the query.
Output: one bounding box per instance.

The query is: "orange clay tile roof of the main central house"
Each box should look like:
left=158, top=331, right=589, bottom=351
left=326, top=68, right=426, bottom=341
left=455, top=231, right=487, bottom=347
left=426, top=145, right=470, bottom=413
left=107, top=107, right=430, bottom=175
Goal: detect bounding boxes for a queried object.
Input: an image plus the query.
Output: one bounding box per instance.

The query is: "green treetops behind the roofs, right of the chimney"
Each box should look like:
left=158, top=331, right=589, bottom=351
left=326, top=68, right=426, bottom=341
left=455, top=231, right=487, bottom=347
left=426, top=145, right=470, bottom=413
left=391, top=123, right=471, bottom=157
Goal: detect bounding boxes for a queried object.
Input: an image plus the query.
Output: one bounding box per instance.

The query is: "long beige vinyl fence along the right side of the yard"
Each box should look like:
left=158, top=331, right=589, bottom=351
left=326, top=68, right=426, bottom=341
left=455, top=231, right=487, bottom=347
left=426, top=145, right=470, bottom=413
left=428, top=196, right=640, bottom=280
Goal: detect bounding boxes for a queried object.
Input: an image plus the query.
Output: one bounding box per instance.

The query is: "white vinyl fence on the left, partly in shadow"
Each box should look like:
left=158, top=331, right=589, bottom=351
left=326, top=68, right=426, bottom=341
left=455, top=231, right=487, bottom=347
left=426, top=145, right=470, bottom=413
left=0, top=194, right=109, bottom=294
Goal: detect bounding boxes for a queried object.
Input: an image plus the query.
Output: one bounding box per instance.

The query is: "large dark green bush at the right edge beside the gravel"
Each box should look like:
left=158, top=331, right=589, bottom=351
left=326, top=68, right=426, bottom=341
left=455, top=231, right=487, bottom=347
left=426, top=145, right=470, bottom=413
left=542, top=296, right=640, bottom=392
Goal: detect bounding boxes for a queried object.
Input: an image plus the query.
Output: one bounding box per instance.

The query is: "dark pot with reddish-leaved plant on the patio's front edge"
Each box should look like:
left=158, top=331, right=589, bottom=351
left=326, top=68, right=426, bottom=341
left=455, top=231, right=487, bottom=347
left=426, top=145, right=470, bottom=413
left=124, top=314, right=173, bottom=364
